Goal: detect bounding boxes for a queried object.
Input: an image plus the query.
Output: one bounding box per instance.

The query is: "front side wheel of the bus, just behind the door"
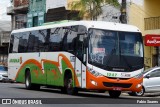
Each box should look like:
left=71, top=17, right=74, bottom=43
left=65, top=74, right=78, bottom=95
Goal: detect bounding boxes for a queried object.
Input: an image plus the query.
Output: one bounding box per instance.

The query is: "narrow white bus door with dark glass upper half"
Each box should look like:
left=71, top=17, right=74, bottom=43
left=75, top=34, right=86, bottom=88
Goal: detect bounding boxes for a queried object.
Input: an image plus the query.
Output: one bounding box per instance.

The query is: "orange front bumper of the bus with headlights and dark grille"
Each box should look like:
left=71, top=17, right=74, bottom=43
left=86, top=72, right=143, bottom=92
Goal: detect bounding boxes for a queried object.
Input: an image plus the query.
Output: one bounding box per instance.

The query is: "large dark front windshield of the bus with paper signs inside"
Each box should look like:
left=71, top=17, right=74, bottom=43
left=88, top=29, right=144, bottom=72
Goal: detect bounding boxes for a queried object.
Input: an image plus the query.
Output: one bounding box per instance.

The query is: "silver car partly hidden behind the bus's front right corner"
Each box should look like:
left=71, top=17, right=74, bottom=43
left=128, top=67, right=160, bottom=96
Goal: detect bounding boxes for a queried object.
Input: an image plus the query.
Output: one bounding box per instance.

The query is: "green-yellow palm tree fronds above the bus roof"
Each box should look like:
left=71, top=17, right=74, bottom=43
left=70, top=0, right=119, bottom=20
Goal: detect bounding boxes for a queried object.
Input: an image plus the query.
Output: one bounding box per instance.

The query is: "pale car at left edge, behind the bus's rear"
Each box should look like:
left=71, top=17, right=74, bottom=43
left=0, top=65, right=9, bottom=82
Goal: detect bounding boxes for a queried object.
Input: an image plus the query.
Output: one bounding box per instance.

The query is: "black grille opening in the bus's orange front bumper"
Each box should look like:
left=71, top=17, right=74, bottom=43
left=103, top=82, right=132, bottom=88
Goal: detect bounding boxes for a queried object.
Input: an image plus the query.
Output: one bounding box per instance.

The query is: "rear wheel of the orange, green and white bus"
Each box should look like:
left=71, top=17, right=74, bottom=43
left=25, top=71, right=40, bottom=90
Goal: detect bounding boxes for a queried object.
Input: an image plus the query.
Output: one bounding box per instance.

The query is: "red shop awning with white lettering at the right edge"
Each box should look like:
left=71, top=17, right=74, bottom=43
left=145, top=34, right=160, bottom=46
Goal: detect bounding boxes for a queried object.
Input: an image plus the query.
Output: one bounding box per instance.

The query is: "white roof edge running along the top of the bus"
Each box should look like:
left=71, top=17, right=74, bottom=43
left=12, top=21, right=140, bottom=33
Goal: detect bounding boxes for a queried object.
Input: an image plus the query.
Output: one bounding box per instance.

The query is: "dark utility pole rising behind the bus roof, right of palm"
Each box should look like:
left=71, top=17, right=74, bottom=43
left=120, top=0, right=127, bottom=24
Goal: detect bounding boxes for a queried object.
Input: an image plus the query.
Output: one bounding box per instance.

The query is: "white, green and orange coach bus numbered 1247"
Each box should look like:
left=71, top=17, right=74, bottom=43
left=8, top=21, right=144, bottom=98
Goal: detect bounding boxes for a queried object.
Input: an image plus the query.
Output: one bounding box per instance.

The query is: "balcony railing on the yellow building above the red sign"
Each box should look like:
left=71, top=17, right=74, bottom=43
left=144, top=16, right=160, bottom=30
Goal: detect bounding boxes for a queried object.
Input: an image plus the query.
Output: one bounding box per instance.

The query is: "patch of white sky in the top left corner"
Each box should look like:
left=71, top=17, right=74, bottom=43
left=0, top=0, right=11, bottom=20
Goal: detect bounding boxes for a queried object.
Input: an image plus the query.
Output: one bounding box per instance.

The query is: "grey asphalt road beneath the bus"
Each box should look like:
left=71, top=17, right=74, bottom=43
left=0, top=83, right=160, bottom=107
